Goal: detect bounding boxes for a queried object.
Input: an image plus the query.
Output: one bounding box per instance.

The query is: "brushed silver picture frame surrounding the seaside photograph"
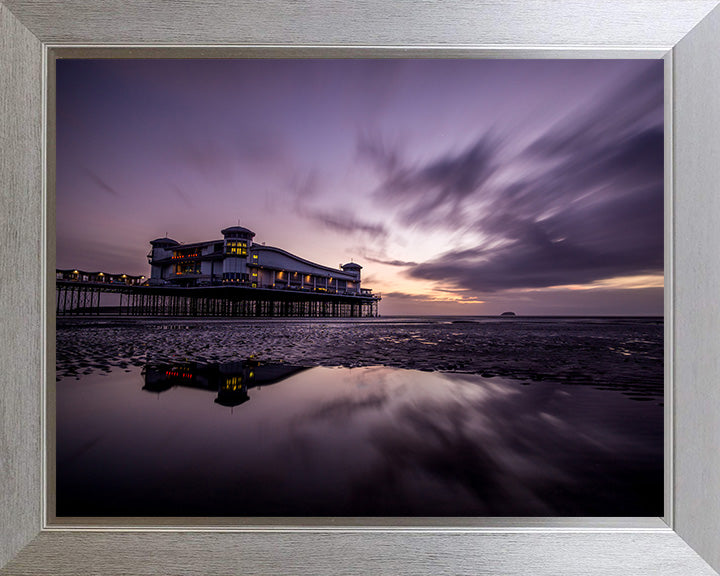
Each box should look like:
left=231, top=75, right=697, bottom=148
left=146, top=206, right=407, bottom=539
left=0, top=0, right=720, bottom=575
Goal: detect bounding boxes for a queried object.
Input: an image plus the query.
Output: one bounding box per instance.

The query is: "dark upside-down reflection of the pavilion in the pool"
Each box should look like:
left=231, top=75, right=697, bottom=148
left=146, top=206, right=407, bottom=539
left=143, top=360, right=307, bottom=407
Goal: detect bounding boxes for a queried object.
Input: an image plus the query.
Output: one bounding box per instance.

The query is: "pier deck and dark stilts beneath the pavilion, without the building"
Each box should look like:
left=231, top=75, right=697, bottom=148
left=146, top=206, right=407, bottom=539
left=55, top=280, right=380, bottom=318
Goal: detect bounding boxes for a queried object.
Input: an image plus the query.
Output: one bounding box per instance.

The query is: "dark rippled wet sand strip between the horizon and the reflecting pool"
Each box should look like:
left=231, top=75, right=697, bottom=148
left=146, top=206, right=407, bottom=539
left=56, top=317, right=663, bottom=402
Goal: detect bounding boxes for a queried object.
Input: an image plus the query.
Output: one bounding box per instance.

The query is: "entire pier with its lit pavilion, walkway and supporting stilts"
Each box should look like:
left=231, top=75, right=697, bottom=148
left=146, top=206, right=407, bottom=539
left=55, top=226, right=381, bottom=318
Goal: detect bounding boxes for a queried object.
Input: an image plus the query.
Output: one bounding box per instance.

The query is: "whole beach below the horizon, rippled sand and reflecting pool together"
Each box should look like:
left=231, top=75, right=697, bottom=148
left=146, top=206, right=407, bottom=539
left=55, top=317, right=664, bottom=517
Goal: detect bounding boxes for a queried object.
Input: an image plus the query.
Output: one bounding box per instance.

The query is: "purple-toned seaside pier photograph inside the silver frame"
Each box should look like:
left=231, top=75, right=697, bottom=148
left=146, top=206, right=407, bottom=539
left=54, top=57, right=666, bottom=521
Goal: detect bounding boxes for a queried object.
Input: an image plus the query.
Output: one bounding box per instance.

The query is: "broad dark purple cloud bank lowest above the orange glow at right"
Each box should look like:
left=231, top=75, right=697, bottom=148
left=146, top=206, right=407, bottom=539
left=410, top=188, right=663, bottom=292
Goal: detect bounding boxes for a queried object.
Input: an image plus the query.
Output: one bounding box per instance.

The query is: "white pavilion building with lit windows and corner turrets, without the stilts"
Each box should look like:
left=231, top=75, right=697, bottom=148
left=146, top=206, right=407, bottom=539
left=148, top=226, right=372, bottom=295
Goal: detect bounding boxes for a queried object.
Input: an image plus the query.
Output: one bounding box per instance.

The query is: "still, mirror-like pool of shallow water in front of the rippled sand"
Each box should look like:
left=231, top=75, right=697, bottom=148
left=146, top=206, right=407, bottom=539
left=56, top=362, right=663, bottom=516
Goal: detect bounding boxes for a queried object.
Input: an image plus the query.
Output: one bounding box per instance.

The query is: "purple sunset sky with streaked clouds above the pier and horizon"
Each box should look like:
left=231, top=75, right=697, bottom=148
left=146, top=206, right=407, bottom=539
left=56, top=59, right=664, bottom=316
